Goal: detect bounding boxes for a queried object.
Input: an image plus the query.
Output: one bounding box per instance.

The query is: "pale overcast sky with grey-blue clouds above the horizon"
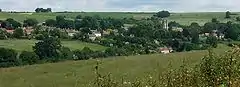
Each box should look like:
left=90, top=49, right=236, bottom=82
left=0, top=0, right=240, bottom=12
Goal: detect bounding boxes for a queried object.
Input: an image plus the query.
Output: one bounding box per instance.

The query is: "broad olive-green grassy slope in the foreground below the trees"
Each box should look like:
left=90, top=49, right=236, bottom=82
left=0, top=45, right=229, bottom=87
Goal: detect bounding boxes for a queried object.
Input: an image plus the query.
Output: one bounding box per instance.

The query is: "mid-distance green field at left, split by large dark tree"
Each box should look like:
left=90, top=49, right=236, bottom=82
left=0, top=40, right=106, bottom=52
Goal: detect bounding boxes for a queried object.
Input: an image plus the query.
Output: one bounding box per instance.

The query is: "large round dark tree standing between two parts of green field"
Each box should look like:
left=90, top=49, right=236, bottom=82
left=33, top=36, right=62, bottom=62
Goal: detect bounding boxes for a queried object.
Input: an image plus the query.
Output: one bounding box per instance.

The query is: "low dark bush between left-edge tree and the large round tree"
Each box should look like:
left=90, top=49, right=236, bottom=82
left=19, top=51, right=40, bottom=65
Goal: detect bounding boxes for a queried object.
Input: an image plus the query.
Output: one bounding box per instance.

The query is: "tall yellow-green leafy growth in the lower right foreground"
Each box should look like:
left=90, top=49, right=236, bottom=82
left=90, top=47, right=240, bottom=87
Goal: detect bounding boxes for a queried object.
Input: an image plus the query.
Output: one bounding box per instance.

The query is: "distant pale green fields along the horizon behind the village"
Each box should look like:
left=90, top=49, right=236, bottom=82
left=0, top=12, right=240, bottom=25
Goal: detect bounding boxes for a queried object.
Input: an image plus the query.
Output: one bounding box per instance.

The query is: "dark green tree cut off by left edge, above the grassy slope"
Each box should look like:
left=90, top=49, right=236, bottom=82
left=0, top=48, right=19, bottom=68
